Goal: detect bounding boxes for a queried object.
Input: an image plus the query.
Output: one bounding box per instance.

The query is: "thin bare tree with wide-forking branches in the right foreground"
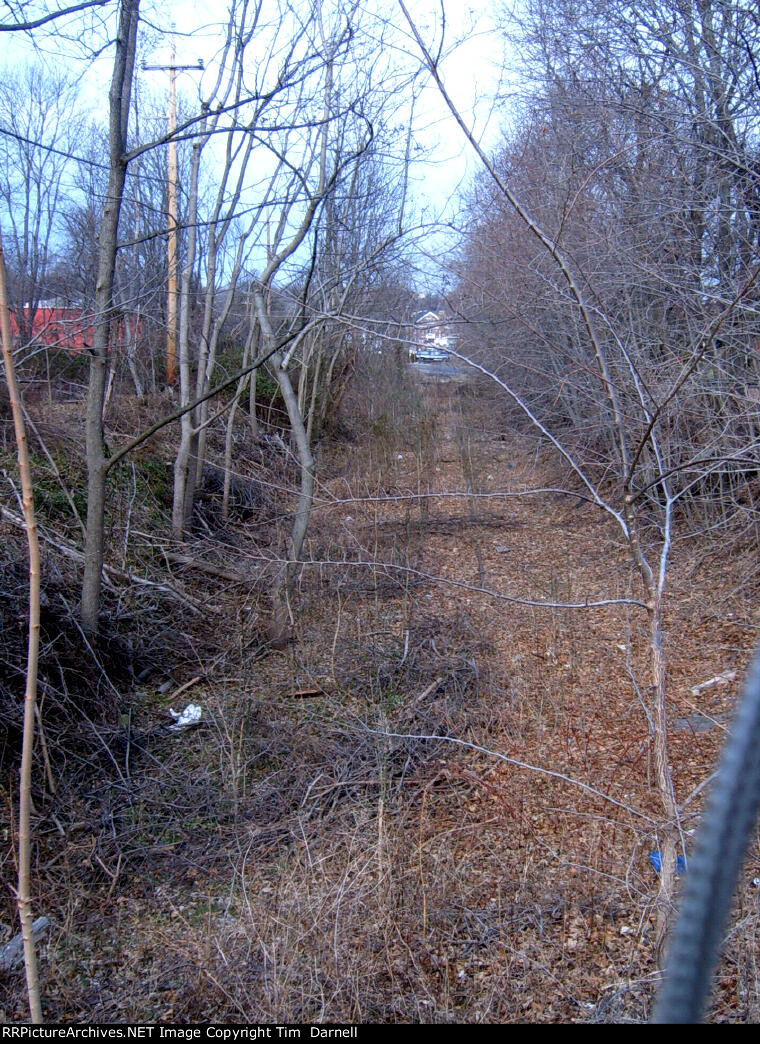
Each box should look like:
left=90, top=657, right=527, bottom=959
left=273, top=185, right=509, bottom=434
left=407, top=0, right=758, bottom=943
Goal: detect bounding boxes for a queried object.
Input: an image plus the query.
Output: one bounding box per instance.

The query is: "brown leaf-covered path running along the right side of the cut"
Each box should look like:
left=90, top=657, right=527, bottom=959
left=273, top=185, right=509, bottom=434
left=288, top=367, right=756, bottom=1019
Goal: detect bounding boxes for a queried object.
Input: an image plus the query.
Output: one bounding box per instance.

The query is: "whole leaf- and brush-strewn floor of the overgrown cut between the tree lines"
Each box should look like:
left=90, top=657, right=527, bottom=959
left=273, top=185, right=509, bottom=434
left=0, top=365, right=760, bottom=1023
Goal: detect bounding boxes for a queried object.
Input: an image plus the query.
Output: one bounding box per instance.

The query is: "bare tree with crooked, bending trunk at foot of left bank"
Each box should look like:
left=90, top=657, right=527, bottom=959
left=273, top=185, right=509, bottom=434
left=242, top=4, right=413, bottom=644
